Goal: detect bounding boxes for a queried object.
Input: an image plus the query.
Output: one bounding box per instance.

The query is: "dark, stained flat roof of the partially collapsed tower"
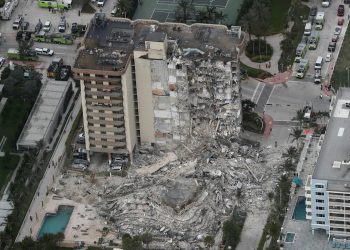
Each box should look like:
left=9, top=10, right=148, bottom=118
left=74, top=13, right=240, bottom=71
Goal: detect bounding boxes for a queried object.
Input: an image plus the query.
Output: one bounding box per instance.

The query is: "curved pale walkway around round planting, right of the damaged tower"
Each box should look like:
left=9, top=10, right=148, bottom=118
left=240, top=34, right=283, bottom=75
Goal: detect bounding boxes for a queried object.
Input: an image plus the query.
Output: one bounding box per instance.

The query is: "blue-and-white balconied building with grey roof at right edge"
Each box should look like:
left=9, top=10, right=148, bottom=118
left=305, top=88, right=350, bottom=237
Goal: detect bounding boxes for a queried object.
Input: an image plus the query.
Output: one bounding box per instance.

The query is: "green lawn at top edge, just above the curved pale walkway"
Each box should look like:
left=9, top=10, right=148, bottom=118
left=269, top=0, right=291, bottom=34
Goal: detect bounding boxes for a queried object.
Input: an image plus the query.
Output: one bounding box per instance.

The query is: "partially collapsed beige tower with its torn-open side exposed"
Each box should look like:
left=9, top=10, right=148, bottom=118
left=73, top=13, right=240, bottom=160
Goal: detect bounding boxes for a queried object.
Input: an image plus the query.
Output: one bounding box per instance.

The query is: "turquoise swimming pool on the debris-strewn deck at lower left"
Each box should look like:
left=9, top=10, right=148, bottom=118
left=38, top=206, right=74, bottom=238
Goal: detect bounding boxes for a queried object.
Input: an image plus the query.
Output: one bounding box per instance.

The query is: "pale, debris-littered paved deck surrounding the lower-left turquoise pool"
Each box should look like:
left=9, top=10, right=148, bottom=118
left=32, top=195, right=104, bottom=245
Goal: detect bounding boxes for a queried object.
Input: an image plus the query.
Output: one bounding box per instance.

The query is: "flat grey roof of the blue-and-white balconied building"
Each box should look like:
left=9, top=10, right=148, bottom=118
left=313, top=88, right=350, bottom=192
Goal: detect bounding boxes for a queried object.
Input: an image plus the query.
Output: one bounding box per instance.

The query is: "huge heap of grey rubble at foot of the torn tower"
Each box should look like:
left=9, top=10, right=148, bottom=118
left=95, top=139, right=282, bottom=249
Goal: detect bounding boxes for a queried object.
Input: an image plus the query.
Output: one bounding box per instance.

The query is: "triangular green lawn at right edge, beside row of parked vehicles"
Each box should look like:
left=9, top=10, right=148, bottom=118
left=330, top=24, right=350, bottom=89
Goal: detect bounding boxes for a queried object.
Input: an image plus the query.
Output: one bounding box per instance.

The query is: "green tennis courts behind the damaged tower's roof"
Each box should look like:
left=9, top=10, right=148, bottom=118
left=133, top=0, right=243, bottom=25
